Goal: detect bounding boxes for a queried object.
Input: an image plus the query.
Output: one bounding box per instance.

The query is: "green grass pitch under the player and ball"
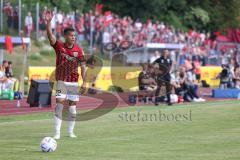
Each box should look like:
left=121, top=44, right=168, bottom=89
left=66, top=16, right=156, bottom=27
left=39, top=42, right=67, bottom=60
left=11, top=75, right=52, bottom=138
left=0, top=101, right=240, bottom=160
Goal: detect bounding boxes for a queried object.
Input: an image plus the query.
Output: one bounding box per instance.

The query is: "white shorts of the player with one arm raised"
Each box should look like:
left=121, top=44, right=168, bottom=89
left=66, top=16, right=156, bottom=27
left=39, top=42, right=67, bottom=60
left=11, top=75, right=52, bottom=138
left=56, top=81, right=79, bottom=102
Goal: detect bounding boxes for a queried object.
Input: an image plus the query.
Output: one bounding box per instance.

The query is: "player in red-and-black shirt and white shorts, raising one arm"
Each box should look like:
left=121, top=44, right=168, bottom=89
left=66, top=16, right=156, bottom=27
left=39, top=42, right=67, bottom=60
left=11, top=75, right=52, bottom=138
left=45, top=11, right=86, bottom=139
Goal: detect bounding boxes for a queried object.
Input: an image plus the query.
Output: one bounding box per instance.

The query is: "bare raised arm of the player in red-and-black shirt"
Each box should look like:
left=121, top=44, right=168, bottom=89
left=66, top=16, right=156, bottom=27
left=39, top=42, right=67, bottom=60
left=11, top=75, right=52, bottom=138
left=45, top=11, right=56, bottom=45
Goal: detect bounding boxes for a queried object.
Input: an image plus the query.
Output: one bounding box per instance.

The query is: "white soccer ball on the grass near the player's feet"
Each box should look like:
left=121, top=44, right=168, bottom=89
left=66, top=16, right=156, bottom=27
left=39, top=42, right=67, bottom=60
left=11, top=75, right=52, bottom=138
left=40, top=137, right=57, bottom=152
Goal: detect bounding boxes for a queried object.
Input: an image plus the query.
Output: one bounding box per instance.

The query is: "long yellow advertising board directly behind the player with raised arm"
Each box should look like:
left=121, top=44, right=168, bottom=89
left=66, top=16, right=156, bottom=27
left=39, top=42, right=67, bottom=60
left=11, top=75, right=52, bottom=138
left=28, top=67, right=140, bottom=91
